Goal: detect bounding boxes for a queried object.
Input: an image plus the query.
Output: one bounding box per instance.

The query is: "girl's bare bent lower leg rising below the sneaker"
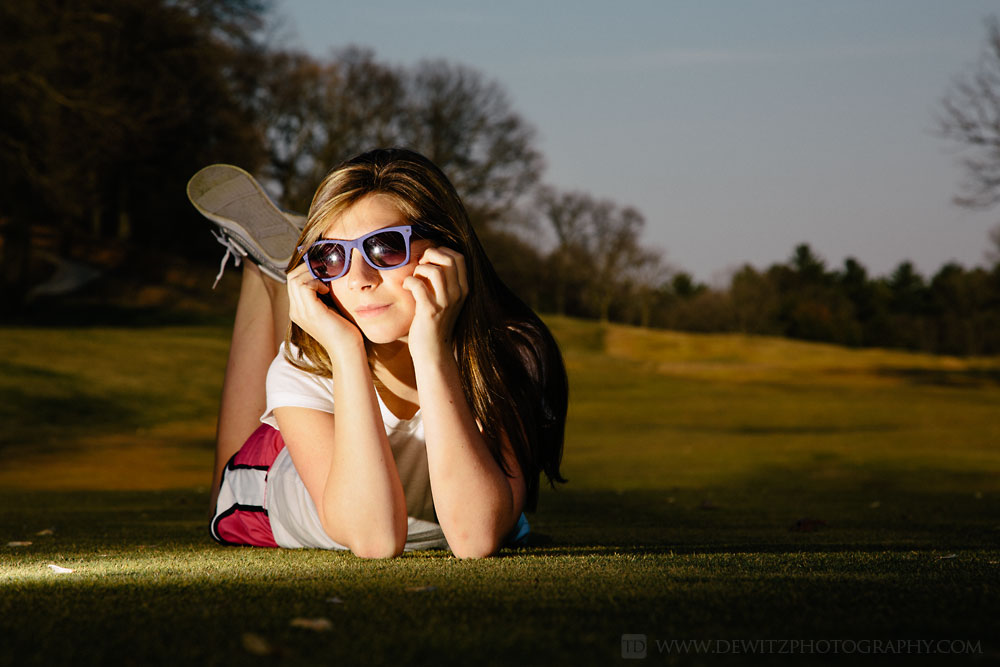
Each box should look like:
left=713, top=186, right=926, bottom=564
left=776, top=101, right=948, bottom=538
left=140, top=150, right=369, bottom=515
left=212, top=262, right=288, bottom=510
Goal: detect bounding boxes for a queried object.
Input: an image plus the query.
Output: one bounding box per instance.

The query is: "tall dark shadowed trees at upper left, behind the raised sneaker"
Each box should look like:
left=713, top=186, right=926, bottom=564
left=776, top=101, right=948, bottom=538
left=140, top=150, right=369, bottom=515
left=0, top=0, right=263, bottom=307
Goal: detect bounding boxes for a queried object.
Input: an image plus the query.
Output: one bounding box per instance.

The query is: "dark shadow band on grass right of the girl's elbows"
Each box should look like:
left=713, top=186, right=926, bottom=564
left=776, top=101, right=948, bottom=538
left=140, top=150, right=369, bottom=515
left=529, top=459, right=1000, bottom=554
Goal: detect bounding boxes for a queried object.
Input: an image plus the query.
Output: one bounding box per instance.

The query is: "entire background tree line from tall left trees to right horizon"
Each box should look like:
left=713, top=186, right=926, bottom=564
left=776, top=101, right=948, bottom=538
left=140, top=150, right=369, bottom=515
left=0, top=0, right=1000, bottom=354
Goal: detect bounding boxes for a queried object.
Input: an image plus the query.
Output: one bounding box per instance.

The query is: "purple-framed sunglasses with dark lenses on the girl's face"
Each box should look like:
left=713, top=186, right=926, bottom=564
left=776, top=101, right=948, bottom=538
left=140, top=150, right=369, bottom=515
left=298, top=225, right=412, bottom=283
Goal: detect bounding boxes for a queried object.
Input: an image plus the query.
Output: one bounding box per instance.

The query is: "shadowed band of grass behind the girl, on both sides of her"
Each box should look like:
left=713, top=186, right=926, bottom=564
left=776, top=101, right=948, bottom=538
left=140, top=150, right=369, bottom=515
left=0, top=461, right=1000, bottom=556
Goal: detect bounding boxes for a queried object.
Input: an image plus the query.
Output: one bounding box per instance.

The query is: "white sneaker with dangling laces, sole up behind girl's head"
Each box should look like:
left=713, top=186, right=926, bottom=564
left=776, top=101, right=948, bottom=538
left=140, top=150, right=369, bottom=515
left=187, top=164, right=306, bottom=283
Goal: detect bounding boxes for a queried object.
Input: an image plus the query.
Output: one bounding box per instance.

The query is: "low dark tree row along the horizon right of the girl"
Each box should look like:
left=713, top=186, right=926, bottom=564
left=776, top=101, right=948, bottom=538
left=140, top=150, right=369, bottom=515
left=592, top=244, right=1000, bottom=355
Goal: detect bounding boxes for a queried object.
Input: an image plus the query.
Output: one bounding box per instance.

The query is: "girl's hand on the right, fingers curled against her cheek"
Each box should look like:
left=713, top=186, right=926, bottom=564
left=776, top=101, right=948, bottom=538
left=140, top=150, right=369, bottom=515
left=403, top=247, right=469, bottom=358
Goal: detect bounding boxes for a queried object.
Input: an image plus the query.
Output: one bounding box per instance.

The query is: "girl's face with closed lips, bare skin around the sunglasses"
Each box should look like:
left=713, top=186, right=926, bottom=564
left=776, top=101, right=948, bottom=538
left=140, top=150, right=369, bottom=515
left=323, top=195, right=431, bottom=344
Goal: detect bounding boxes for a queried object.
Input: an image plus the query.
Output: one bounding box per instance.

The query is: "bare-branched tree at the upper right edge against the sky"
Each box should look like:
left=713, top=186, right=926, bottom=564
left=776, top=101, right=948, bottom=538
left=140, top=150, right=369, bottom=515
left=938, top=17, right=1000, bottom=209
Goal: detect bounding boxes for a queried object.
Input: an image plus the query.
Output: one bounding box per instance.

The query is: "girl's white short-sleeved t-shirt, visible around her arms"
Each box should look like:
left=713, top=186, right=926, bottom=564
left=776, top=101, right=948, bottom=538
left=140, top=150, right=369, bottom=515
left=260, top=343, right=448, bottom=550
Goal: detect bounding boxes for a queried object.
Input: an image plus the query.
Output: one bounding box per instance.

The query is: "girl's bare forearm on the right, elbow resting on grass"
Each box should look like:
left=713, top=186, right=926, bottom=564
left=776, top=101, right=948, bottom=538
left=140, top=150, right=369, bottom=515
left=414, top=355, right=515, bottom=557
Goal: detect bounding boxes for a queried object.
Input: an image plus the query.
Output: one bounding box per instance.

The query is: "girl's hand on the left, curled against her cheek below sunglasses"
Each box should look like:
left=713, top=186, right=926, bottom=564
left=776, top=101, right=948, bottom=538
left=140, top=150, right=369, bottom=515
left=287, top=263, right=364, bottom=359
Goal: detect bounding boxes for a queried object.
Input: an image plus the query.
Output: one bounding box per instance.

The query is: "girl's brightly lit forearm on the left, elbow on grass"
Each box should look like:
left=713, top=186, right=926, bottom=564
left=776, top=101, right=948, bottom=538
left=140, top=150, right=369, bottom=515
left=322, top=354, right=406, bottom=555
